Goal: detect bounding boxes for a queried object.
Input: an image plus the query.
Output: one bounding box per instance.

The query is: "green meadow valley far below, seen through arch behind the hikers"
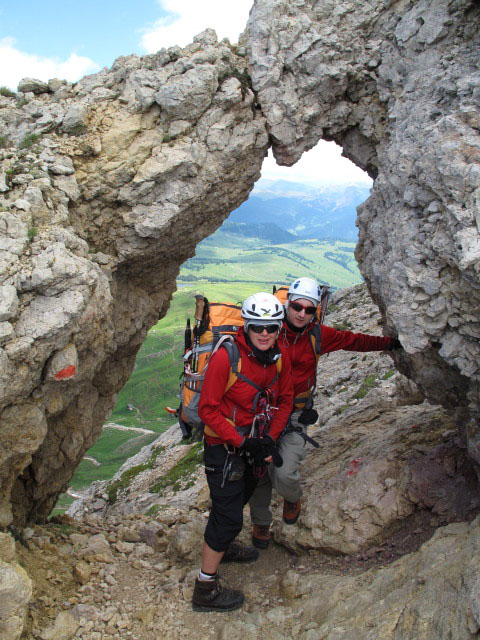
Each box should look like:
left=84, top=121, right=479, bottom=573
left=62, top=229, right=361, bottom=498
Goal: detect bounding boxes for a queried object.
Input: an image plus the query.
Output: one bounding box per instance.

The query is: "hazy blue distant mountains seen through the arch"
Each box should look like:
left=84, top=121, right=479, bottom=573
left=229, top=180, right=370, bottom=242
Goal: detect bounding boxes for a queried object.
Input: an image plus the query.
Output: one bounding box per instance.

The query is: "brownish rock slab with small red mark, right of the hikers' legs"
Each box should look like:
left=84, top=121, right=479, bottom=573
left=275, top=392, right=480, bottom=554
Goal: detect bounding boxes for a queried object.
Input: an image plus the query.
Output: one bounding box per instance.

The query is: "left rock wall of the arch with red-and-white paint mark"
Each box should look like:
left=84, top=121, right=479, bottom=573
left=0, top=30, right=268, bottom=526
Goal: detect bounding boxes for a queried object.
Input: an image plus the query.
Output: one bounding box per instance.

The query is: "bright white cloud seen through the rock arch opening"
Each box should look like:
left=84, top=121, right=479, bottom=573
left=262, top=140, right=372, bottom=186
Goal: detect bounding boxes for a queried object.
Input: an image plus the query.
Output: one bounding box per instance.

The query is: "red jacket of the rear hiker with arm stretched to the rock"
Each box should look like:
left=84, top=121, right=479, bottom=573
left=278, top=321, right=393, bottom=398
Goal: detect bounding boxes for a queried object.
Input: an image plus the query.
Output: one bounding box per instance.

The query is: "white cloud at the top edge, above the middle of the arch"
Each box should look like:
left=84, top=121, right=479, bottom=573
left=140, top=0, right=253, bottom=53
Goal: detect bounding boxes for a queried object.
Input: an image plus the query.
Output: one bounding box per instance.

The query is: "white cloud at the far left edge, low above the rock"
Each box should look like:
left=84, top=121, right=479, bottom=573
left=0, top=38, right=100, bottom=90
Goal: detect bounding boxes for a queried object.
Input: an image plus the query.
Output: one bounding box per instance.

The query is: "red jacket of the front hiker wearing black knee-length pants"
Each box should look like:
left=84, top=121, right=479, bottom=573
left=198, top=327, right=293, bottom=447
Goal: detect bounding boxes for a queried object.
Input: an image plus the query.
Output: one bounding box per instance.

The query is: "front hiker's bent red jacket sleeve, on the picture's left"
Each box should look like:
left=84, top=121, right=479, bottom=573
left=198, top=349, right=243, bottom=447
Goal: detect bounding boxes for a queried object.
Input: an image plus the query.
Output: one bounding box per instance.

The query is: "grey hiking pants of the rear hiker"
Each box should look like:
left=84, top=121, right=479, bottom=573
left=249, top=414, right=307, bottom=525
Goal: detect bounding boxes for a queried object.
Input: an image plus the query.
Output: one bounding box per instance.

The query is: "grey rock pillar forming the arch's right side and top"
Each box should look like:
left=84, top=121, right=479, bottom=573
left=244, top=0, right=480, bottom=461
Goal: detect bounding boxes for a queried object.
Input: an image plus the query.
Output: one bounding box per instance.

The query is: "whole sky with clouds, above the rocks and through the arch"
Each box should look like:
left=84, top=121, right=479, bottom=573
left=0, top=0, right=368, bottom=184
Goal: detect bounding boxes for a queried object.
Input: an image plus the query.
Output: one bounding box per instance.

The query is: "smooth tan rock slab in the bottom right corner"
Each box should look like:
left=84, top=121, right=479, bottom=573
left=284, top=518, right=480, bottom=640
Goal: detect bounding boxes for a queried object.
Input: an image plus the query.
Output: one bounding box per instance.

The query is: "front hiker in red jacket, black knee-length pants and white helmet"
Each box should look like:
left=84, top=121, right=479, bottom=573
left=192, top=293, right=293, bottom=611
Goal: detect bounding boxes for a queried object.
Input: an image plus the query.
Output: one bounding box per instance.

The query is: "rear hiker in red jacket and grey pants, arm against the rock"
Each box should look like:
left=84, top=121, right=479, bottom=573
left=250, top=278, right=401, bottom=549
